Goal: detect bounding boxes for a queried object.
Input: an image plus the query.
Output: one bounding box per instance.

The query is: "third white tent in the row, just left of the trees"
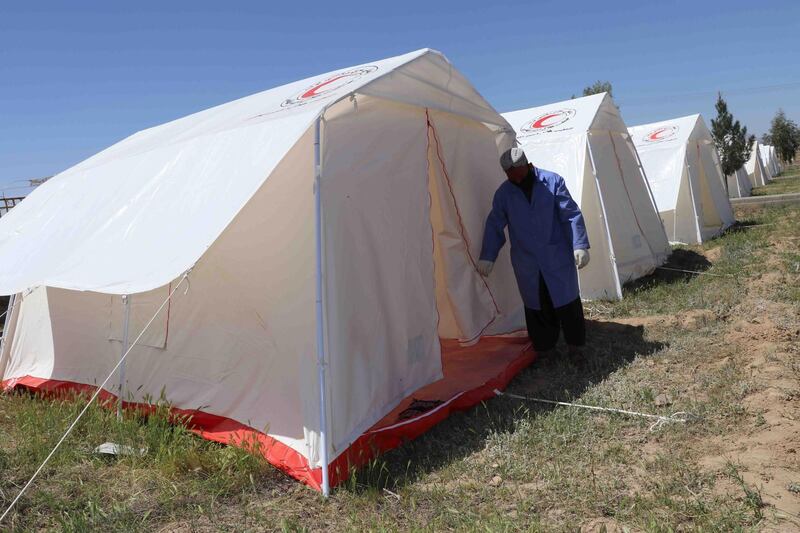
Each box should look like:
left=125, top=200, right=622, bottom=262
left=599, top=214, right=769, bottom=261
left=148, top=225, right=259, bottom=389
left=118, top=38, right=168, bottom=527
left=629, top=115, right=735, bottom=244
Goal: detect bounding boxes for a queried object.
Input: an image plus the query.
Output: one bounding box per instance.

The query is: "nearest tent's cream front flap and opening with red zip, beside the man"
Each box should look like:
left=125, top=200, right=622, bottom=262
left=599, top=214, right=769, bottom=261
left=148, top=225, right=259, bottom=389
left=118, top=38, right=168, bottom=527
left=428, top=111, right=525, bottom=334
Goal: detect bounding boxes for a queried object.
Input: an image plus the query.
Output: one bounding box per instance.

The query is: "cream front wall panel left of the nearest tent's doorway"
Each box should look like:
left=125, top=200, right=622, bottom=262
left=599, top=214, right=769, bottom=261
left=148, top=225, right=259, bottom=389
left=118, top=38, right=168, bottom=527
left=322, top=97, right=441, bottom=458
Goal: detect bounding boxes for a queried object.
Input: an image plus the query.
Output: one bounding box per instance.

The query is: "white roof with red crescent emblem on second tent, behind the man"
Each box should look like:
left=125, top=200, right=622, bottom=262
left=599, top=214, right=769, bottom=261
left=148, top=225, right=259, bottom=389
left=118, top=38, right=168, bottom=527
left=503, top=93, right=610, bottom=144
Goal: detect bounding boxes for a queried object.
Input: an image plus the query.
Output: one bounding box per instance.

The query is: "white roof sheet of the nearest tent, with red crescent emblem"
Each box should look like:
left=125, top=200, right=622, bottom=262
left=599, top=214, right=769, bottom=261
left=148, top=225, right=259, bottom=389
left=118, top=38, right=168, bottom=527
left=0, top=49, right=510, bottom=294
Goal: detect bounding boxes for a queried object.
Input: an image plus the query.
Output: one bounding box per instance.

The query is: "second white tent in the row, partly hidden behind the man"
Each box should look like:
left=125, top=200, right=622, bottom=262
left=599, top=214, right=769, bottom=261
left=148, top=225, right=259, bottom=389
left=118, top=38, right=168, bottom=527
left=503, top=93, right=670, bottom=299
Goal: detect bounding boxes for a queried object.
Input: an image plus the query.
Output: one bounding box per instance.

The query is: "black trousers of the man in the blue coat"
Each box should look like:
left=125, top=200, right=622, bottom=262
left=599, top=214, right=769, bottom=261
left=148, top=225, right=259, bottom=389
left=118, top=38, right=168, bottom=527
left=525, top=273, right=586, bottom=352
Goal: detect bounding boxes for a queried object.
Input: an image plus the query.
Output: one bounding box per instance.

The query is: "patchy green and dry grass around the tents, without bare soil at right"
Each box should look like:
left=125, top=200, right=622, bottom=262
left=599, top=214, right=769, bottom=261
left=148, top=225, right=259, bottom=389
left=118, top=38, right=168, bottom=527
left=0, top=165, right=800, bottom=531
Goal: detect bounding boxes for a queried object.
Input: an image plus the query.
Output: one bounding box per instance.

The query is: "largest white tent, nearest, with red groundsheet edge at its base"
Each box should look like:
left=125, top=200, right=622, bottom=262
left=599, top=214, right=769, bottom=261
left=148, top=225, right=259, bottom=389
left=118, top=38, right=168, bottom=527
left=0, top=50, right=524, bottom=490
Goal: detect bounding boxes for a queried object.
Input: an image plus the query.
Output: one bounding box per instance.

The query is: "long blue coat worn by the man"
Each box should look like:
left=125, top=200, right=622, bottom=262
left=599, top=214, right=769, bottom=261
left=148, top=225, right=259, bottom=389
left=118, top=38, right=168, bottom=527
left=481, top=169, right=589, bottom=310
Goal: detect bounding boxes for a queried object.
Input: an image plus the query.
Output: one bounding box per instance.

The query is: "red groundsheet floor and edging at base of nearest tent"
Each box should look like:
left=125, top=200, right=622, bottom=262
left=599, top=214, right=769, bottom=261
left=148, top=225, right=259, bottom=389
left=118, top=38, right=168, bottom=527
left=0, top=337, right=536, bottom=490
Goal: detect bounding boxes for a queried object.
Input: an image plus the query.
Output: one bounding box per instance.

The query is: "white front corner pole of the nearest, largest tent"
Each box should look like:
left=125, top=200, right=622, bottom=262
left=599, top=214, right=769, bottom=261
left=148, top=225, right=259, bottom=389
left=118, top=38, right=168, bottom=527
left=314, top=116, right=331, bottom=498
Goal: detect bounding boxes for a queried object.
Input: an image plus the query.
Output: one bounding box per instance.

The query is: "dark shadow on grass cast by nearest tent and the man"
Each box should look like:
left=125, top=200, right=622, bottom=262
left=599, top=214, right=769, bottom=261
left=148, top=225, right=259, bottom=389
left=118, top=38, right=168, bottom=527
left=340, top=320, right=666, bottom=493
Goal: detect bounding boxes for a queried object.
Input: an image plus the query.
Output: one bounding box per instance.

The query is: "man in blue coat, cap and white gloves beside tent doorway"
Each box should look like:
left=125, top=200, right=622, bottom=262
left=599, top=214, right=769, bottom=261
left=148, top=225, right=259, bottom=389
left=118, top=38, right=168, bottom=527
left=478, top=148, right=589, bottom=364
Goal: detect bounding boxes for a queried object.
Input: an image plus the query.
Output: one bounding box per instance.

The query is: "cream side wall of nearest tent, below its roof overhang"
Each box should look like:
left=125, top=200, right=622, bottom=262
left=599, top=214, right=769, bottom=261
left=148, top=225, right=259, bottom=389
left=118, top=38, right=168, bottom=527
left=0, top=124, right=319, bottom=461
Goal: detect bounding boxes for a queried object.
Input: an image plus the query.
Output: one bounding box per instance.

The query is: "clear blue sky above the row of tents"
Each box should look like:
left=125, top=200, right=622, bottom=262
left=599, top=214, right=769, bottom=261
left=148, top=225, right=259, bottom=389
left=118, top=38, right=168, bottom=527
left=0, top=0, right=800, bottom=195
